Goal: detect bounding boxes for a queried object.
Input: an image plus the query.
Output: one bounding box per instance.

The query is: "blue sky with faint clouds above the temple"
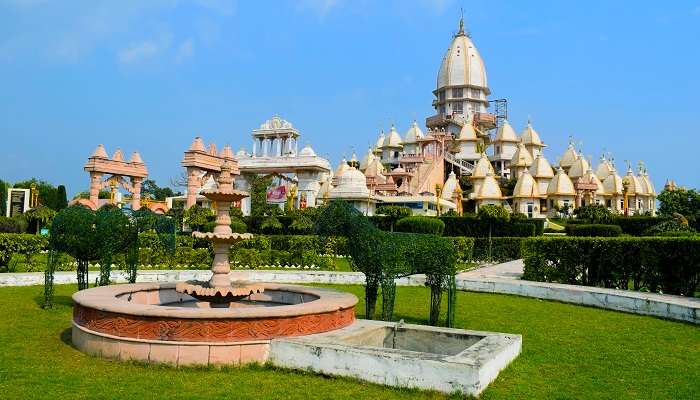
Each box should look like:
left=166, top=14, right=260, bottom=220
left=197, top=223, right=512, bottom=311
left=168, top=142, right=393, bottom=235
left=0, top=0, right=700, bottom=193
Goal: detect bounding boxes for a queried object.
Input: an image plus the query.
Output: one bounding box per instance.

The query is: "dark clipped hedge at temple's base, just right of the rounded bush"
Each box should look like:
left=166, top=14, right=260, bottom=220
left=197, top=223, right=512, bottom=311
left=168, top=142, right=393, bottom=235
left=440, top=216, right=544, bottom=237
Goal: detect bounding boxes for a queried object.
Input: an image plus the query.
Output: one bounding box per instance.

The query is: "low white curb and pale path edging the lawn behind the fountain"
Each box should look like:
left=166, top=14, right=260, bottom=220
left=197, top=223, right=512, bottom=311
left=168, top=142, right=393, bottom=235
left=0, top=260, right=700, bottom=325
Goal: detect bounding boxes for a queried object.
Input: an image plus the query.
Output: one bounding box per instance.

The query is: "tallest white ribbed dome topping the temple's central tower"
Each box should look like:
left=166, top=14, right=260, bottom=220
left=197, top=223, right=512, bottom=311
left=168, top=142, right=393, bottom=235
left=436, top=21, right=491, bottom=95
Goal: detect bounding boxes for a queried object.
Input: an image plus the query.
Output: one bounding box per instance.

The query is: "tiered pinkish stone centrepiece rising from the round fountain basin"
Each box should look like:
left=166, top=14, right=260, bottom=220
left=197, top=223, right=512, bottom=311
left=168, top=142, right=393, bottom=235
left=175, top=160, right=264, bottom=307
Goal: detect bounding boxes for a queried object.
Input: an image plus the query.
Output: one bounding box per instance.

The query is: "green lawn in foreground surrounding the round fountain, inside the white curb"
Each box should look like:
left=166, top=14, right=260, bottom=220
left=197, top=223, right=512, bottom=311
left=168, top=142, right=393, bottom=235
left=0, top=286, right=700, bottom=400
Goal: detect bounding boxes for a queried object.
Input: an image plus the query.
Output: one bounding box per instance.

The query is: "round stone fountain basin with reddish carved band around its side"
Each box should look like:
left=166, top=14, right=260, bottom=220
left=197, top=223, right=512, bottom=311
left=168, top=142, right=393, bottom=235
left=72, top=283, right=357, bottom=365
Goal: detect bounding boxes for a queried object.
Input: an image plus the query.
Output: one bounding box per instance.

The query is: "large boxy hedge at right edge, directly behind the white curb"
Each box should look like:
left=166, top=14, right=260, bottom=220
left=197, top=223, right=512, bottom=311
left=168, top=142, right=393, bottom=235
left=523, top=237, right=700, bottom=296
